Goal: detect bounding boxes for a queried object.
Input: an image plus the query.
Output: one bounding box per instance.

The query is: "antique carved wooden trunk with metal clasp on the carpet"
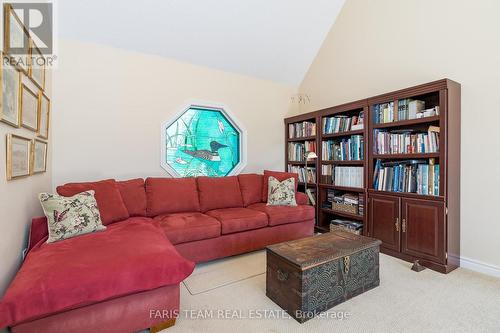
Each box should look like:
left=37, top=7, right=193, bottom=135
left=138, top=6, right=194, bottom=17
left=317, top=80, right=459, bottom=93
left=266, top=231, right=381, bottom=323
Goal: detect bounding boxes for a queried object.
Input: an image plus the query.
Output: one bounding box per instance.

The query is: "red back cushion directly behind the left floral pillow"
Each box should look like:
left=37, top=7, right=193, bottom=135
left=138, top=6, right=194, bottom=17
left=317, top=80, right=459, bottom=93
left=57, top=179, right=129, bottom=225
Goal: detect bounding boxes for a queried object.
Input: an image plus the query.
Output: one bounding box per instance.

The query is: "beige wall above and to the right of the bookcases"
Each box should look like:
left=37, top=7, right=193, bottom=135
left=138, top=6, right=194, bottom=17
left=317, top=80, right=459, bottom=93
left=299, top=0, right=500, bottom=272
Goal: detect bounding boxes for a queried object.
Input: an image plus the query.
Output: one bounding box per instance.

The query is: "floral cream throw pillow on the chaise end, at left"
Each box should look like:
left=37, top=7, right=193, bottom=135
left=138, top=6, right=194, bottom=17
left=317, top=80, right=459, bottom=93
left=39, top=191, right=106, bottom=243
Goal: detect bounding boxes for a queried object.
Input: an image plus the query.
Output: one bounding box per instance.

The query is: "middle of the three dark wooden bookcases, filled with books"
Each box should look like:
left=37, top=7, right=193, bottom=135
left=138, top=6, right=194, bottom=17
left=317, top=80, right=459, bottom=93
left=317, top=100, right=368, bottom=233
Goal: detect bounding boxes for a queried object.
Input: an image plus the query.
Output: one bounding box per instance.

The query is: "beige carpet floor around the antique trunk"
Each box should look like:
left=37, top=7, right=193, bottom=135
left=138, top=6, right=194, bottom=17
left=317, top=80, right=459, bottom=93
left=164, top=250, right=500, bottom=333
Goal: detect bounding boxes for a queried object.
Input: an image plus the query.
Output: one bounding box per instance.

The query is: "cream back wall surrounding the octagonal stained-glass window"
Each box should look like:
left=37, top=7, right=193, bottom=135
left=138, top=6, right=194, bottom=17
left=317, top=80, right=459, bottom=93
left=53, top=40, right=295, bottom=185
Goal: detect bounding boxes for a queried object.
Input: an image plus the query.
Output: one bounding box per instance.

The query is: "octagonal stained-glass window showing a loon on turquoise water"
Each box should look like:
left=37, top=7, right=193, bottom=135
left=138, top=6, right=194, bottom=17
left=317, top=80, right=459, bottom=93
left=162, top=106, right=242, bottom=177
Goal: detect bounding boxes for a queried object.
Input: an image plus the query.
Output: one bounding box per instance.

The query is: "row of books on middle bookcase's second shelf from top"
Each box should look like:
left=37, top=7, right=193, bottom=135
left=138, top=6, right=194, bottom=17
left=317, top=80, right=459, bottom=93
left=321, top=135, right=364, bottom=161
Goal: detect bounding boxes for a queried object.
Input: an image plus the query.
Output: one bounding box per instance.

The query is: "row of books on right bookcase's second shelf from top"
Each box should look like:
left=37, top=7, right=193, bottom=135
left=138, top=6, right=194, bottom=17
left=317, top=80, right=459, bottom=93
left=373, top=126, right=439, bottom=154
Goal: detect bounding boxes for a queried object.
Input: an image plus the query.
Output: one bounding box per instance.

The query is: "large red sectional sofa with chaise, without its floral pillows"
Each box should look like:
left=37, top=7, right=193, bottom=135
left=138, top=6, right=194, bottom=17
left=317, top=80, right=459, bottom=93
left=0, top=171, right=315, bottom=333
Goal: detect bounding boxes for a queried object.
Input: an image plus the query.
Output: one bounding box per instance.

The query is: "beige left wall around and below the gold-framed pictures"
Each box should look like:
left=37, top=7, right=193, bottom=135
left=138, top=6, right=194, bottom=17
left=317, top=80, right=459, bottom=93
left=0, top=72, right=52, bottom=296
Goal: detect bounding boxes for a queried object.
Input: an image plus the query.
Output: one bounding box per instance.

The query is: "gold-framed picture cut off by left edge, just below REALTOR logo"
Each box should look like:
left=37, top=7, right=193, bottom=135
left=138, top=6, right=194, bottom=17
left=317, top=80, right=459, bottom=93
left=0, top=53, right=22, bottom=127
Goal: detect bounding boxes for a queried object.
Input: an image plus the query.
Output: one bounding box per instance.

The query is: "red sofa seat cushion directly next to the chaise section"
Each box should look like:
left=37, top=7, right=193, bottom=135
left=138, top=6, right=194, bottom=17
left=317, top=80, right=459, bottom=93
left=154, top=212, right=221, bottom=244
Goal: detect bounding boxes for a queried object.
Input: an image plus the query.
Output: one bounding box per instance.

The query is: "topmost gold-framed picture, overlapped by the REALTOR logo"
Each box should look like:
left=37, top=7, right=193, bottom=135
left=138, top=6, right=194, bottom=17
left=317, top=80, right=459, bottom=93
left=3, top=4, right=31, bottom=75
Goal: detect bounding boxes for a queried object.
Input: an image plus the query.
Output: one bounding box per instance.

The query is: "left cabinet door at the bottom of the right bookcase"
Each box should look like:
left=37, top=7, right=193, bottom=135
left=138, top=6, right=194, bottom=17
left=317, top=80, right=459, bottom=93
left=369, top=194, right=401, bottom=251
